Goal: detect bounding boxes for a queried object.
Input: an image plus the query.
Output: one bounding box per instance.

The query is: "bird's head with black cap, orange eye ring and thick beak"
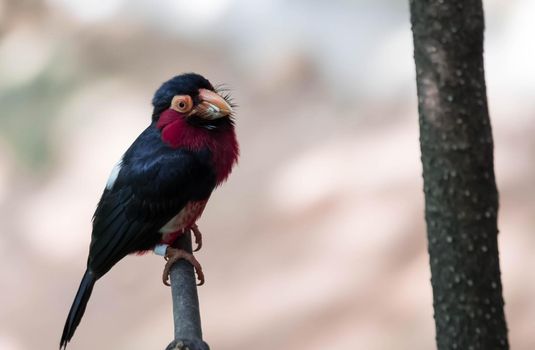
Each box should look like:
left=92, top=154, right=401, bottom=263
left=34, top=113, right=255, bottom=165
left=152, top=73, right=233, bottom=130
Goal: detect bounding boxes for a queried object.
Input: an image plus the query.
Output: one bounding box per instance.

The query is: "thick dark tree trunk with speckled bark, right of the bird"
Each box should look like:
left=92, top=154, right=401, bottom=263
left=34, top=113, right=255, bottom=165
left=409, top=0, right=509, bottom=350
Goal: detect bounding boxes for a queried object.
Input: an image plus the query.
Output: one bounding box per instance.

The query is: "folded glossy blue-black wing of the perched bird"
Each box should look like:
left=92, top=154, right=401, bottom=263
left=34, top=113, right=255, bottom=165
left=88, top=149, right=215, bottom=276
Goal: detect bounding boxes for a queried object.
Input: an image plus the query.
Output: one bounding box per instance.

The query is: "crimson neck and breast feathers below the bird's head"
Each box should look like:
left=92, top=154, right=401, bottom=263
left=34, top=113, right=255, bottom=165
left=157, top=111, right=239, bottom=185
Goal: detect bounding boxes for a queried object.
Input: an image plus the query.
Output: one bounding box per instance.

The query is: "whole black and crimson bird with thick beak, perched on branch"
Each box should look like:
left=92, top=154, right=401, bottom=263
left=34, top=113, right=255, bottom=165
left=60, top=73, right=239, bottom=349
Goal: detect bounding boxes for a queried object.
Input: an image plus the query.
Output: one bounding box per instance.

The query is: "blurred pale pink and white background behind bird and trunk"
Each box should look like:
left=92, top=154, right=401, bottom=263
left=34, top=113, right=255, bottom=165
left=0, top=0, right=535, bottom=350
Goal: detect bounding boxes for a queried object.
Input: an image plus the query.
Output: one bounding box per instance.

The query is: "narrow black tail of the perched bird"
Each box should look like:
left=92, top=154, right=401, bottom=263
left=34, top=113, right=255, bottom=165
left=59, top=270, right=97, bottom=349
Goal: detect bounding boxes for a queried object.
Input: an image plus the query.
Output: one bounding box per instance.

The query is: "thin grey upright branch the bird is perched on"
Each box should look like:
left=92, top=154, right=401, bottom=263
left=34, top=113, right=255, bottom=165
left=166, top=231, right=209, bottom=350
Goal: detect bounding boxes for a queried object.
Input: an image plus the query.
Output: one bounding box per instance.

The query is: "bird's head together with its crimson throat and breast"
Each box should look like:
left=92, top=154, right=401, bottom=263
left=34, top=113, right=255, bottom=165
left=152, top=73, right=239, bottom=175
